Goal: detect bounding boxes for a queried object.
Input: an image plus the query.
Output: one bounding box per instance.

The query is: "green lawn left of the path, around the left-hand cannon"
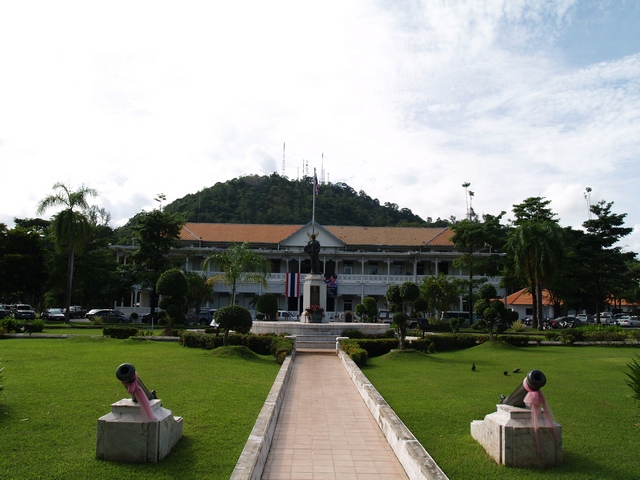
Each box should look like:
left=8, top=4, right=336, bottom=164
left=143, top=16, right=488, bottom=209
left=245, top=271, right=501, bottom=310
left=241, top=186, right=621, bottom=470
left=0, top=338, right=280, bottom=480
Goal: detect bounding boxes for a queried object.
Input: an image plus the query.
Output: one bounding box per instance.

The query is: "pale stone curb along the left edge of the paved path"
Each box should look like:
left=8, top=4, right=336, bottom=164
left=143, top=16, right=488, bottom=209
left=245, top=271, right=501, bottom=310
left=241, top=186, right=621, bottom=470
left=231, top=348, right=296, bottom=480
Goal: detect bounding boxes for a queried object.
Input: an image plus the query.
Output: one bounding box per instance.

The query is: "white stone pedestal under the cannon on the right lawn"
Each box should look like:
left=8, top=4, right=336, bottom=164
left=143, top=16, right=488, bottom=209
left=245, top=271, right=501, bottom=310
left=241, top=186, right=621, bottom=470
left=471, top=404, right=562, bottom=468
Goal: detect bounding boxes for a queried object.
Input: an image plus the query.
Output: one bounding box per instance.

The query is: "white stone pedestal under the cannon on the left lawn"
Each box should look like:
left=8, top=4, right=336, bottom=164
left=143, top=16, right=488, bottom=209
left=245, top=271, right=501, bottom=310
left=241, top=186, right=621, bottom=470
left=96, top=398, right=182, bottom=463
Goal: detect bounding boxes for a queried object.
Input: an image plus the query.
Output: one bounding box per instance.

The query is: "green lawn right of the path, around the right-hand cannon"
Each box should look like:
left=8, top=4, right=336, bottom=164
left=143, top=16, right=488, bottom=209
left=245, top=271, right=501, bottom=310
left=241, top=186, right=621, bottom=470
left=363, top=343, right=640, bottom=480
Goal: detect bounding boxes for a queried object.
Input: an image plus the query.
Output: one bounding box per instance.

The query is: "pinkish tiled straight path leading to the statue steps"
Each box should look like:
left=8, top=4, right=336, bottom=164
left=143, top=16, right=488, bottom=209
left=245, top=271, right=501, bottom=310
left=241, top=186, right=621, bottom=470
left=262, top=353, right=407, bottom=480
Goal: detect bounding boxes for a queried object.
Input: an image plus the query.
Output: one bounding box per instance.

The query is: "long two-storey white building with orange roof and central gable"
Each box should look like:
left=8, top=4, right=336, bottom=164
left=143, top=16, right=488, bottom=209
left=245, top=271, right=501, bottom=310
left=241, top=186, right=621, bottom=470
left=115, top=222, right=504, bottom=320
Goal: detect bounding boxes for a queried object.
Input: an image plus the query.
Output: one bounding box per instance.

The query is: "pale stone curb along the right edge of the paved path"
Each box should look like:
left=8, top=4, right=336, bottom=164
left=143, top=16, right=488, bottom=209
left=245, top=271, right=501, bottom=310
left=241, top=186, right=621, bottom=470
left=338, top=350, right=448, bottom=480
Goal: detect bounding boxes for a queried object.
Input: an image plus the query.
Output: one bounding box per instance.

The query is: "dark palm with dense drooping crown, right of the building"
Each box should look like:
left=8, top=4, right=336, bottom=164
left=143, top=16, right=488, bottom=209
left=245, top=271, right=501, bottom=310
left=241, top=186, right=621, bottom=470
left=509, top=220, right=564, bottom=329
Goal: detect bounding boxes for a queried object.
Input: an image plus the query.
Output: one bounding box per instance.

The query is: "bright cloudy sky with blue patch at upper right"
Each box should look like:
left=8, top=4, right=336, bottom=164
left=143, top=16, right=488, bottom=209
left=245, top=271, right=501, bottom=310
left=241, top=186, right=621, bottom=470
left=0, top=0, right=640, bottom=252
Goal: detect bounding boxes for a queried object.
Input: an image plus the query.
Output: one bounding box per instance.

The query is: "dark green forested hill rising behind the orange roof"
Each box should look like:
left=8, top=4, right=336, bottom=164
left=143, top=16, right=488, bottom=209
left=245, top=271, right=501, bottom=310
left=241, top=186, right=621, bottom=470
left=164, top=173, right=449, bottom=227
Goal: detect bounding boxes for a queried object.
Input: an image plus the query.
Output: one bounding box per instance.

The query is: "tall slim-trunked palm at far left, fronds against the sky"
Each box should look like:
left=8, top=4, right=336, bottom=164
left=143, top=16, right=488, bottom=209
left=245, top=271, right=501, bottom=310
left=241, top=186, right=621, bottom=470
left=37, top=182, right=98, bottom=322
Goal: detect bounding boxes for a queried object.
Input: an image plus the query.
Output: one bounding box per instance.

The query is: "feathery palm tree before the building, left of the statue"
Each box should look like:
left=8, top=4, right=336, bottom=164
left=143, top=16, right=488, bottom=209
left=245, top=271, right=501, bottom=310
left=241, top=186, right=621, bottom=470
left=202, top=242, right=271, bottom=305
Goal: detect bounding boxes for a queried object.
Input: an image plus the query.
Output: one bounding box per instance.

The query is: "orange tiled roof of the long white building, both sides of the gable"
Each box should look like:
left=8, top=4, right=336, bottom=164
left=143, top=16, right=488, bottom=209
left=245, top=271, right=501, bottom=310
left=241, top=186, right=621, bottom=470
left=180, top=223, right=453, bottom=247
